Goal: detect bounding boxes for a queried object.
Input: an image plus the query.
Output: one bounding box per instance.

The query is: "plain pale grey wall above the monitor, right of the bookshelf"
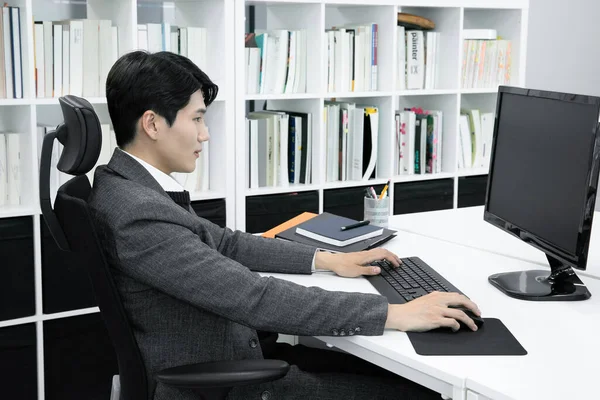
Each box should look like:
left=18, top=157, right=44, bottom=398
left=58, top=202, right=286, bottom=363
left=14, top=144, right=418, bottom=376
left=525, top=0, right=600, bottom=95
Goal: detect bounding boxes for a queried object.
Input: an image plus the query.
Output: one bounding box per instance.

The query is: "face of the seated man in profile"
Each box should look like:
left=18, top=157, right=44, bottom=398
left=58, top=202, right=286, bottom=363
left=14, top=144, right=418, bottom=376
left=157, top=90, right=210, bottom=174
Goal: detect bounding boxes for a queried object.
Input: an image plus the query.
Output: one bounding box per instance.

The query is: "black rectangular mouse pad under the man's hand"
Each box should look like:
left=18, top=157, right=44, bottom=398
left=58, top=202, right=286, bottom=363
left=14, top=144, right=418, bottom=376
left=407, top=318, right=527, bottom=356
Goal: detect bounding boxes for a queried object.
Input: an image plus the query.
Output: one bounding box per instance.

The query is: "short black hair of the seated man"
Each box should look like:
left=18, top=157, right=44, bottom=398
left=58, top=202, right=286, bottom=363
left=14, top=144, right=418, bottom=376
left=106, top=50, right=218, bottom=148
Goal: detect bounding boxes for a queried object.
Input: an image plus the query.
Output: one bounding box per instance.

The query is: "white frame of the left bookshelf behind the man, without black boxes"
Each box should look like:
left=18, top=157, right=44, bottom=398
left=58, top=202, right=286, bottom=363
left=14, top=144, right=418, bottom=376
left=0, top=0, right=235, bottom=400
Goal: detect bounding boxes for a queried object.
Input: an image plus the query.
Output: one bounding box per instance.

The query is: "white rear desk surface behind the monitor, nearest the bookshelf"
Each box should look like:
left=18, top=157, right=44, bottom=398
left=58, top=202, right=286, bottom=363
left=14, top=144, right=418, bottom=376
left=389, top=206, right=600, bottom=280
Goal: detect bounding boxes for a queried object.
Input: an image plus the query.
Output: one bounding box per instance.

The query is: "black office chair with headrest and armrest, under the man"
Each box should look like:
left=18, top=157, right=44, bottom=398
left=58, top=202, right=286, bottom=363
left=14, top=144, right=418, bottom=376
left=39, top=95, right=289, bottom=400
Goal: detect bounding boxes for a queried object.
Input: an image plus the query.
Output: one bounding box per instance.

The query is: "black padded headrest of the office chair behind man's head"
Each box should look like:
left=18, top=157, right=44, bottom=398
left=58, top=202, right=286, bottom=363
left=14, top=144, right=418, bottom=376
left=57, top=95, right=102, bottom=175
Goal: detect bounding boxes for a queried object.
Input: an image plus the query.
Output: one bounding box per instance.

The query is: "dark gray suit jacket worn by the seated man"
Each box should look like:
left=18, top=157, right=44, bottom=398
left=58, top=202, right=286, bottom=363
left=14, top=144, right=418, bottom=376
left=89, top=149, right=387, bottom=400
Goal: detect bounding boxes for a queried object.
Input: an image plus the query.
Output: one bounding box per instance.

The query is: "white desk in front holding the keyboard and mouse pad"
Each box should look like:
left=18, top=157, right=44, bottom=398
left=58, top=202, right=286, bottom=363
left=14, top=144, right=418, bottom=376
left=264, top=228, right=600, bottom=400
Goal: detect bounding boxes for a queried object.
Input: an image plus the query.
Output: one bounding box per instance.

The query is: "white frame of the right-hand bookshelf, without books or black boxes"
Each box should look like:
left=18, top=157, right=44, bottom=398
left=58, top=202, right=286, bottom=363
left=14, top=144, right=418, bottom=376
left=235, top=0, right=529, bottom=230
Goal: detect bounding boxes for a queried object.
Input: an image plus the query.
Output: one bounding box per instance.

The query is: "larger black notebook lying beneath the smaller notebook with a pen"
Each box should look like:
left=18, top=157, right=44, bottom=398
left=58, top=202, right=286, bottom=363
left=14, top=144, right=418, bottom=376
left=275, top=213, right=396, bottom=253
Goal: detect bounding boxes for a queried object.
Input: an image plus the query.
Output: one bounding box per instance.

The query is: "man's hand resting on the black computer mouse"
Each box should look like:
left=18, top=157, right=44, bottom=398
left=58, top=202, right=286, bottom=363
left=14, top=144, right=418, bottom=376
left=385, top=292, right=481, bottom=332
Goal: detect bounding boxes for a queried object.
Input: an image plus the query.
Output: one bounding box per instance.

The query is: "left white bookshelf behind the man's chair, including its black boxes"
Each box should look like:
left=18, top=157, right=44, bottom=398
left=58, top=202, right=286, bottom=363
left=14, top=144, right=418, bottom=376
left=0, top=0, right=235, bottom=400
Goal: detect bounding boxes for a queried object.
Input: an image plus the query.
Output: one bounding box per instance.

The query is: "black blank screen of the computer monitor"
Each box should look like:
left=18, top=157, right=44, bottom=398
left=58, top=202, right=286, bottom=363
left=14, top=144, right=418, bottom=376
left=487, top=93, right=598, bottom=254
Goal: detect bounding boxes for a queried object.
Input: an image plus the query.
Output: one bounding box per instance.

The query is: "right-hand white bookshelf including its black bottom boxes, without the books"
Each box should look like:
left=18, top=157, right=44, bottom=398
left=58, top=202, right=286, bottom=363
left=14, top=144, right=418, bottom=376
left=235, top=0, right=529, bottom=231
